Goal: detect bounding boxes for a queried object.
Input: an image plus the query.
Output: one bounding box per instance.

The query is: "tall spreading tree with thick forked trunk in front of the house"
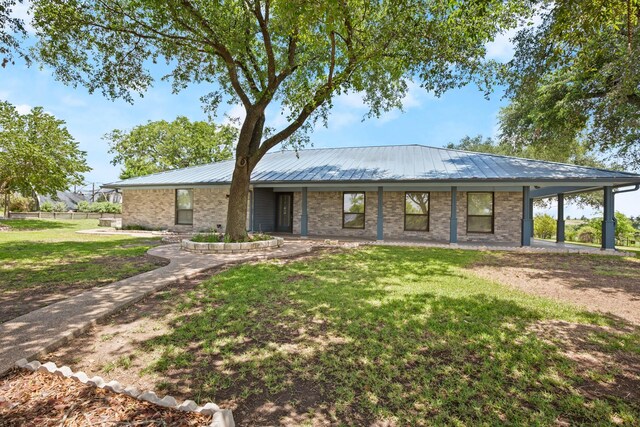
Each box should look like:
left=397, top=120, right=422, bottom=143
left=33, top=0, right=531, bottom=239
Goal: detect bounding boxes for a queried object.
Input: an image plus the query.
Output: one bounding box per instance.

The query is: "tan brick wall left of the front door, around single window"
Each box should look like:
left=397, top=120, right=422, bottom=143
left=122, top=187, right=250, bottom=231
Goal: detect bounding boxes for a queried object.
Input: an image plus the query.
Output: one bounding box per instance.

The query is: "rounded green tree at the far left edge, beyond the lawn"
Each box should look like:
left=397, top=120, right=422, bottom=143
left=0, top=102, right=91, bottom=217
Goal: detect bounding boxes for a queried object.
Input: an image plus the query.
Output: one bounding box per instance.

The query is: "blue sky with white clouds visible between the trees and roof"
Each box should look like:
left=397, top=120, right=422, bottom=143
left=0, top=7, right=640, bottom=221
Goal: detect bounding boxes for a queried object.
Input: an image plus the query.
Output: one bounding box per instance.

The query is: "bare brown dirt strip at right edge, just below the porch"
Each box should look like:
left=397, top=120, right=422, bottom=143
left=470, top=253, right=640, bottom=325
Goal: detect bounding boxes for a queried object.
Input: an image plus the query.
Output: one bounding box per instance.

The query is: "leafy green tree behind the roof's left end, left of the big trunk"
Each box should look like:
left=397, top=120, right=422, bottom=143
left=104, top=116, right=238, bottom=179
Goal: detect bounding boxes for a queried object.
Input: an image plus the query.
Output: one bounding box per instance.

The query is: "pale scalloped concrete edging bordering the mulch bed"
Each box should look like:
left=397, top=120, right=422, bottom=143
left=16, top=359, right=235, bottom=427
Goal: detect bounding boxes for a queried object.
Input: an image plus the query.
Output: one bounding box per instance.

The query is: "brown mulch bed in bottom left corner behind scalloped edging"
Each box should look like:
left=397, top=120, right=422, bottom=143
left=0, top=371, right=211, bottom=427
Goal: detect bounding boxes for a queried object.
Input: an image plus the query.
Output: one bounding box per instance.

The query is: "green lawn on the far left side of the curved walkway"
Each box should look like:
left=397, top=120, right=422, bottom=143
left=0, top=219, right=165, bottom=322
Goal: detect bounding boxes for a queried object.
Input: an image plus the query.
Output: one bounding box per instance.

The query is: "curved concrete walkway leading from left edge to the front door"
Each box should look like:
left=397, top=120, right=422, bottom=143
left=0, top=241, right=312, bottom=376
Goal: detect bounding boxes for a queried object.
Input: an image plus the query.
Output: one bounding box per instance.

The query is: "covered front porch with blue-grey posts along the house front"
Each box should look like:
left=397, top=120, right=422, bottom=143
left=250, top=181, right=640, bottom=253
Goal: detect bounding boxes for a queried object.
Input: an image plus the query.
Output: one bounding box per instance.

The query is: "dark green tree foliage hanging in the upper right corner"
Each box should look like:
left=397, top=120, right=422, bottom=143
left=501, top=0, right=640, bottom=168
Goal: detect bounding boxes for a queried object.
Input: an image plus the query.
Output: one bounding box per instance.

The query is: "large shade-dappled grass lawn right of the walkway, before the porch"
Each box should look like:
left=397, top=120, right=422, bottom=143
left=140, top=247, right=640, bottom=425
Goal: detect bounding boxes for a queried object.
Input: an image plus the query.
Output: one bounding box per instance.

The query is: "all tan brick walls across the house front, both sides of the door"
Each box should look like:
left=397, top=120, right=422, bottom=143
left=122, top=187, right=522, bottom=243
